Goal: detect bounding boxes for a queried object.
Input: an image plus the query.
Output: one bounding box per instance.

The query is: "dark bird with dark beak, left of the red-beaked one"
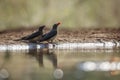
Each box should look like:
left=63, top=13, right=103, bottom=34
left=17, top=25, right=45, bottom=42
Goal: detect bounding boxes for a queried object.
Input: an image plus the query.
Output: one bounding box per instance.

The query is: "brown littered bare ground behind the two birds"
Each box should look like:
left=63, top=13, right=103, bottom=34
left=0, top=28, right=120, bottom=44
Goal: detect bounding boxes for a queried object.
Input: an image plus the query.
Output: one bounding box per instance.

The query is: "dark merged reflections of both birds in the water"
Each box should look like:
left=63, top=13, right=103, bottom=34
left=28, top=48, right=57, bottom=68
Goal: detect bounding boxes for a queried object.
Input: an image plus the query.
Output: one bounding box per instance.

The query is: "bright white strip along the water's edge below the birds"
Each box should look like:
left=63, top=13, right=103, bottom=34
left=0, top=42, right=120, bottom=51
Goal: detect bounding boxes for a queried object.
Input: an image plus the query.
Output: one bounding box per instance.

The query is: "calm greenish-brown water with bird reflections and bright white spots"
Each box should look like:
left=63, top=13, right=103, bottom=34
left=0, top=49, right=120, bottom=80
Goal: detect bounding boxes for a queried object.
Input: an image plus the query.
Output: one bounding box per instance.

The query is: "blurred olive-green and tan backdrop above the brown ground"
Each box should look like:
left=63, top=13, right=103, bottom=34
left=0, top=0, right=120, bottom=30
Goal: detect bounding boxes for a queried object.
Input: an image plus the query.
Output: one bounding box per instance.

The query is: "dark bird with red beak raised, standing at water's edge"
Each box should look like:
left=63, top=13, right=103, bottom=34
left=39, top=22, right=60, bottom=43
